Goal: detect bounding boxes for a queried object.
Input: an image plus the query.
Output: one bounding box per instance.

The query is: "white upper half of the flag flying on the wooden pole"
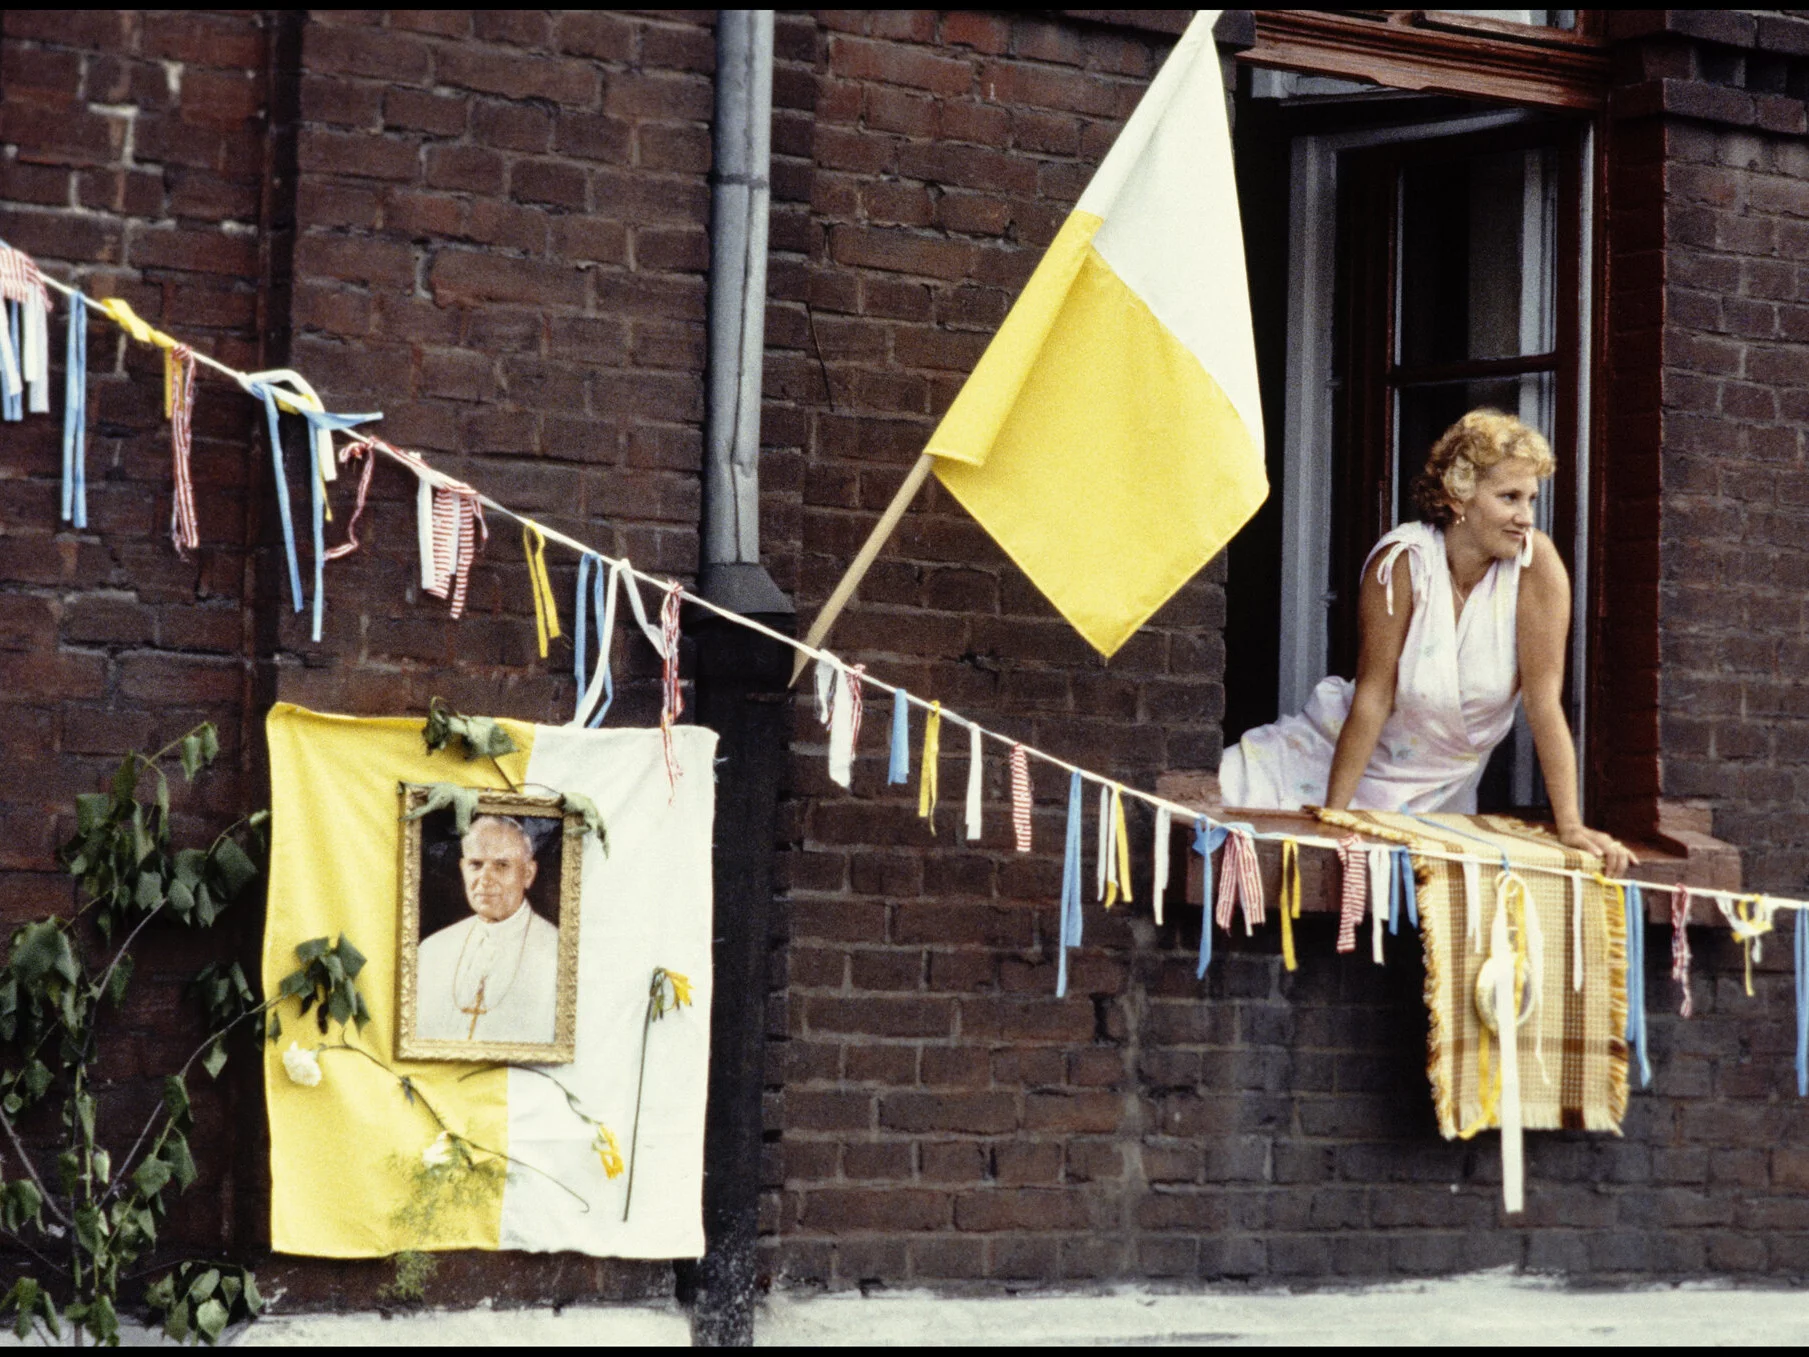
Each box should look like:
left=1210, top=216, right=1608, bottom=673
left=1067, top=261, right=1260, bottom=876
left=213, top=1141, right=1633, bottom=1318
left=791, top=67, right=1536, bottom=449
left=1076, top=9, right=1263, bottom=451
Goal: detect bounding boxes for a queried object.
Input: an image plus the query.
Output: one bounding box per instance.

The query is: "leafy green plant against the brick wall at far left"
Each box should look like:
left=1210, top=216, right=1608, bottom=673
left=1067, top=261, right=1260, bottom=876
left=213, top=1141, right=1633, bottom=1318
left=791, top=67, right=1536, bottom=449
left=0, top=726, right=264, bottom=1344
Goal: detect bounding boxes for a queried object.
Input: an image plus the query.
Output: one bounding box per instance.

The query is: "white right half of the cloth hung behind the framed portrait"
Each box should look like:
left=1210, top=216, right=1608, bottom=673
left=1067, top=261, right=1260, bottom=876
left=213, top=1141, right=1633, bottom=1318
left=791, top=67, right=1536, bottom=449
left=499, top=726, right=716, bottom=1257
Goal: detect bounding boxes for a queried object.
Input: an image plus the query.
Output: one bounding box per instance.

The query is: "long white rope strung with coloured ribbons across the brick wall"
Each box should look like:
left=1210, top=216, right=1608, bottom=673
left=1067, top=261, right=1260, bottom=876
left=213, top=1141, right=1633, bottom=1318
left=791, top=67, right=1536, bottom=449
left=43, top=275, right=1809, bottom=910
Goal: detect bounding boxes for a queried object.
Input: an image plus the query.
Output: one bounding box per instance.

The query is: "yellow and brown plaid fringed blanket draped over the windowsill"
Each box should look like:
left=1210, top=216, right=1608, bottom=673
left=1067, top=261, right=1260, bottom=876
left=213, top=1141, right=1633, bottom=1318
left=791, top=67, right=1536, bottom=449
left=1324, top=811, right=1628, bottom=1140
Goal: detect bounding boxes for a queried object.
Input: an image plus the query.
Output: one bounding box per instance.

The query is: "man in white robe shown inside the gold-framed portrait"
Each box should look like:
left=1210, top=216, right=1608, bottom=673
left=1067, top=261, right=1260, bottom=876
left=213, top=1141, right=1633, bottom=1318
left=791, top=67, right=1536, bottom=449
left=414, top=814, right=559, bottom=1044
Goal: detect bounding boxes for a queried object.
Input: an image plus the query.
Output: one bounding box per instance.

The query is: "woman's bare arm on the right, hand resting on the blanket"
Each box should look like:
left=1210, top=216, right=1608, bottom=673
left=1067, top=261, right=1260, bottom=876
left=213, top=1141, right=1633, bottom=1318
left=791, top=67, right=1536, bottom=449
left=1518, top=532, right=1639, bottom=876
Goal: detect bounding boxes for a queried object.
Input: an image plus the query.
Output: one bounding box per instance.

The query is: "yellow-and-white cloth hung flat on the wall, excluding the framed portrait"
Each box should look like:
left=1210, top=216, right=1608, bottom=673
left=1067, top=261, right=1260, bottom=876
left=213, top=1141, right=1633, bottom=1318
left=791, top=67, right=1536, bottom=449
left=264, top=704, right=716, bottom=1257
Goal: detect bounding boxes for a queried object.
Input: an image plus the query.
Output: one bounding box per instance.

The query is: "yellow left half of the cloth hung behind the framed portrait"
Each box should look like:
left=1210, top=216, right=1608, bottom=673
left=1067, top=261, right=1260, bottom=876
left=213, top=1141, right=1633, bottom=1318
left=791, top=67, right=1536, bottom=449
left=264, top=704, right=534, bottom=1257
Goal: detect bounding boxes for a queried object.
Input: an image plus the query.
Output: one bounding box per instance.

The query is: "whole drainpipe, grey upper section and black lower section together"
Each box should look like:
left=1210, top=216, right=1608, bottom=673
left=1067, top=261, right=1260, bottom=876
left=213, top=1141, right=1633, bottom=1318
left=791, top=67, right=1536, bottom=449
left=678, top=9, right=792, bottom=1346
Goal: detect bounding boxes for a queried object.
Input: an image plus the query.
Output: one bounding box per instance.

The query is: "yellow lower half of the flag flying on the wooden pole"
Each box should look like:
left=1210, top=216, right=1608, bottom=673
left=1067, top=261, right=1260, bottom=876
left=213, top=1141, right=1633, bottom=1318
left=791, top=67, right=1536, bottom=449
left=928, top=242, right=1268, bottom=655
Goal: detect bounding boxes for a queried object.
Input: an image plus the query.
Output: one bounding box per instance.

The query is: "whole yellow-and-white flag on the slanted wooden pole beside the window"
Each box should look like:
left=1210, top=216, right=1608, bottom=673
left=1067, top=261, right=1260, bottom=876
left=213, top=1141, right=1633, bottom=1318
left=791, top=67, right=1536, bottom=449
left=924, top=9, right=1268, bottom=655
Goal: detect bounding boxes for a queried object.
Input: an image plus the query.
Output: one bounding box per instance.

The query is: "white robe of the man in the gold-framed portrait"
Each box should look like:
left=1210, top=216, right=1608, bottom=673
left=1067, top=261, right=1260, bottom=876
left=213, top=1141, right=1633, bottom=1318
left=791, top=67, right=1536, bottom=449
left=416, top=903, right=559, bottom=1042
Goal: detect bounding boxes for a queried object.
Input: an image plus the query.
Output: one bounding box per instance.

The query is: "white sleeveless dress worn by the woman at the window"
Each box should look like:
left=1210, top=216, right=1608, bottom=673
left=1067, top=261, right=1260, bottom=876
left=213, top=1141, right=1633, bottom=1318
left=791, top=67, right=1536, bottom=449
left=1219, top=523, right=1532, bottom=814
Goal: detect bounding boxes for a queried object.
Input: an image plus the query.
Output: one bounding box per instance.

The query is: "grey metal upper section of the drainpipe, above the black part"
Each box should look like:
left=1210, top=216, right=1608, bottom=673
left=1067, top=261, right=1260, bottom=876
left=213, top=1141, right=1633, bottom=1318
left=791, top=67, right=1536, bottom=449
left=698, top=9, right=792, bottom=613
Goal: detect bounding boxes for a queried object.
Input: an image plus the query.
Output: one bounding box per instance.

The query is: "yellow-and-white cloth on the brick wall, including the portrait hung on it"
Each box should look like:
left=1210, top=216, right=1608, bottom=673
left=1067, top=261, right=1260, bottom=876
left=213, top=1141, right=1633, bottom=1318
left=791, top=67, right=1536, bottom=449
left=262, top=704, right=716, bottom=1257
